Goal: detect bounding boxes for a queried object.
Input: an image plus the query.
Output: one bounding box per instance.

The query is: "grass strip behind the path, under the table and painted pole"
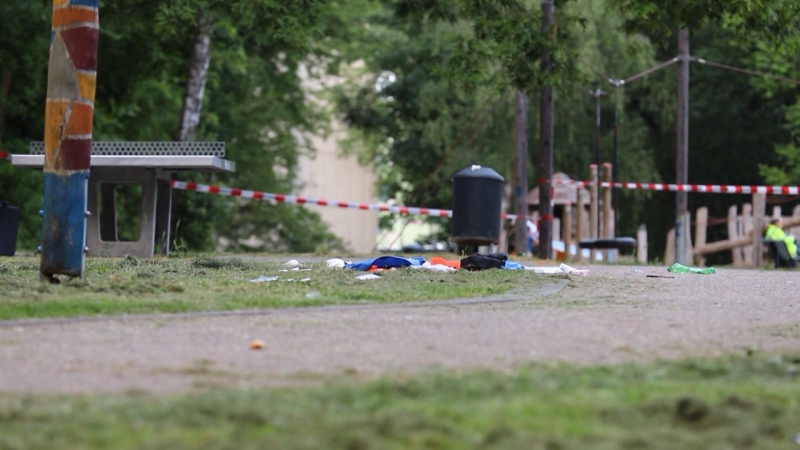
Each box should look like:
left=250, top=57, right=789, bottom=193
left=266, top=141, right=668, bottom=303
left=0, top=257, right=545, bottom=320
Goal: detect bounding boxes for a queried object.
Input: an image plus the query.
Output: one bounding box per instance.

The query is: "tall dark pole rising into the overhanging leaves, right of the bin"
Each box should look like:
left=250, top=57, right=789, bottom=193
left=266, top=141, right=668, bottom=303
left=539, top=0, right=555, bottom=259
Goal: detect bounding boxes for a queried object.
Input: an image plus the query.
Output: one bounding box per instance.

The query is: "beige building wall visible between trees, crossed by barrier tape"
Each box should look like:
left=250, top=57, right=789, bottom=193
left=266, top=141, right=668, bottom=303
left=298, top=133, right=378, bottom=253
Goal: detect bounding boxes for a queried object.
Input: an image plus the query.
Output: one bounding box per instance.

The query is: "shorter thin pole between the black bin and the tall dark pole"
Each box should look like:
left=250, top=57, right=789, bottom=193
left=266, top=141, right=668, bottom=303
left=514, top=91, right=528, bottom=255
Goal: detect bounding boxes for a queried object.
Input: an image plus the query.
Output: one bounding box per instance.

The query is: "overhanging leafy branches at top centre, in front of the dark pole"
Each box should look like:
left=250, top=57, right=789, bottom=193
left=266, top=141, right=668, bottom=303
left=387, top=0, right=585, bottom=91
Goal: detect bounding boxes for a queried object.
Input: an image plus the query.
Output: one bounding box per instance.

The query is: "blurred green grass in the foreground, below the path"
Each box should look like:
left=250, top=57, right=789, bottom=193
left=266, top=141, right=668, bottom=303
left=0, top=357, right=800, bottom=450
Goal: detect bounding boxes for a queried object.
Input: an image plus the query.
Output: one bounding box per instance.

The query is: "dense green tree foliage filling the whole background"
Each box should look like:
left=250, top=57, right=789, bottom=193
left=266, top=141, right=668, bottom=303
left=0, top=0, right=800, bottom=258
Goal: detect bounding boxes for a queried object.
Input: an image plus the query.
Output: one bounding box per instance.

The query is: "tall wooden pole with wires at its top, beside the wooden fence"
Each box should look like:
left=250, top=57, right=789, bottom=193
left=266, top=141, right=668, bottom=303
left=675, top=28, right=690, bottom=264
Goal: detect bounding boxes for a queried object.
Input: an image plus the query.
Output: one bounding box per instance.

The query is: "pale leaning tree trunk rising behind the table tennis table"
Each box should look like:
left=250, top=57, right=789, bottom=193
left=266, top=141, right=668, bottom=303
left=175, top=9, right=212, bottom=141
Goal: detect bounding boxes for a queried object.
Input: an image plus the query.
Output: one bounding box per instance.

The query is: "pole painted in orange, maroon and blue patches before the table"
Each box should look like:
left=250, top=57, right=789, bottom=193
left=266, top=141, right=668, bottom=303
left=40, top=0, right=99, bottom=281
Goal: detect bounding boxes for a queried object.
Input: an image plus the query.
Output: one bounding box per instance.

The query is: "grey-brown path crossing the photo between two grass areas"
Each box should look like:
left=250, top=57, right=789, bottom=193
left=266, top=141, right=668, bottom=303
left=0, top=266, right=800, bottom=392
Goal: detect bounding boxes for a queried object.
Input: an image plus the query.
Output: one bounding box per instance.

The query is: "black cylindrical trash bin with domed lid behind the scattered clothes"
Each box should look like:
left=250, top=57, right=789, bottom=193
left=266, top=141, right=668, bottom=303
left=450, top=166, right=505, bottom=246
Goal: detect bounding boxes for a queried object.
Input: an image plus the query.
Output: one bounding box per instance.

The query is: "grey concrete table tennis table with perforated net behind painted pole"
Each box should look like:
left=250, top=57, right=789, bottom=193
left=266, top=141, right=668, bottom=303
left=11, top=141, right=236, bottom=258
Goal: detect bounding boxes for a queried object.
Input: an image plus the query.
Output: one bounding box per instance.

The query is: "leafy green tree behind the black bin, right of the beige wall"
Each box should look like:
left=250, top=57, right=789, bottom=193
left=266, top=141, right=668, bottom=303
left=338, top=7, right=512, bottom=208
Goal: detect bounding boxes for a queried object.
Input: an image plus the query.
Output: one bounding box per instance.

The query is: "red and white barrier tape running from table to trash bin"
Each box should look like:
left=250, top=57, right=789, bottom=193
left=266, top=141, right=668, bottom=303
left=170, top=180, right=526, bottom=219
